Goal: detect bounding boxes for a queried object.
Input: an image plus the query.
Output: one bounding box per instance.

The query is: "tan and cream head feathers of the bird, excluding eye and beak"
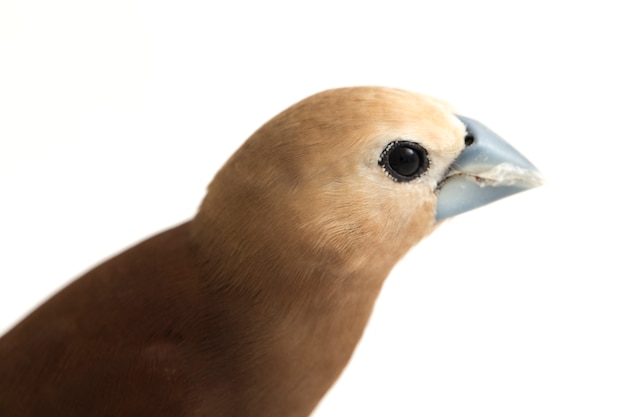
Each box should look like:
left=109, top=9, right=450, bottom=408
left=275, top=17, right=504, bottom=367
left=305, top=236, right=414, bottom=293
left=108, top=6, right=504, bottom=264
left=193, top=87, right=465, bottom=282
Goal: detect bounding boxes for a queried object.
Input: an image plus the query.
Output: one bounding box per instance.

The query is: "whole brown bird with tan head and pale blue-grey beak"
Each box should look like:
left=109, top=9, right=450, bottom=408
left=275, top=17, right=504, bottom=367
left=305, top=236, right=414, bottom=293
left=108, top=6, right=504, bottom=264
left=0, top=87, right=542, bottom=417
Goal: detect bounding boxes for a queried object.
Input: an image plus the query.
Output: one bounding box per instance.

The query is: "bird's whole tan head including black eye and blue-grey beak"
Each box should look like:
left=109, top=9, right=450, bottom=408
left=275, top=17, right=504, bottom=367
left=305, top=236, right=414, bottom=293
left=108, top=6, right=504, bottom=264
left=193, top=87, right=539, bottom=276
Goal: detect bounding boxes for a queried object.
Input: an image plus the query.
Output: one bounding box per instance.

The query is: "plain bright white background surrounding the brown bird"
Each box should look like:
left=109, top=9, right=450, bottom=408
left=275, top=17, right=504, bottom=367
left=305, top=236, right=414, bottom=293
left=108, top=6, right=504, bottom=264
left=0, top=0, right=626, bottom=417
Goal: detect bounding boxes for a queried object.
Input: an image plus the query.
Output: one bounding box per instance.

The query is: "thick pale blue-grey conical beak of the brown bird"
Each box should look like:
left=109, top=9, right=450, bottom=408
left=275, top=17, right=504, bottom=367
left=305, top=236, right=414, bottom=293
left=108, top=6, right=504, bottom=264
left=435, top=116, right=543, bottom=221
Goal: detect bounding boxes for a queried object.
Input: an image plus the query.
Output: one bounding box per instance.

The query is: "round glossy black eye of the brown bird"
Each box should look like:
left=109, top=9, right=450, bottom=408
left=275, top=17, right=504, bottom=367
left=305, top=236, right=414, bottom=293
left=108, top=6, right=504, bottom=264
left=378, top=141, right=429, bottom=181
